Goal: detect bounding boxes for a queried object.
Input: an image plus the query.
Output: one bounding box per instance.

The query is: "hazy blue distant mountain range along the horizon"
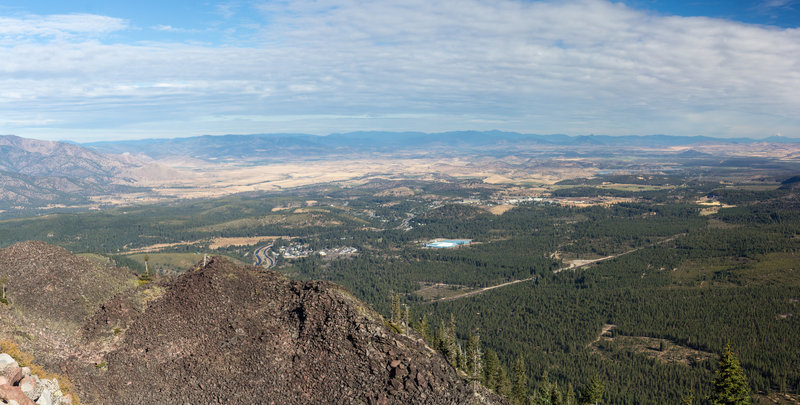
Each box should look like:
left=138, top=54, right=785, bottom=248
left=83, top=131, right=800, bottom=161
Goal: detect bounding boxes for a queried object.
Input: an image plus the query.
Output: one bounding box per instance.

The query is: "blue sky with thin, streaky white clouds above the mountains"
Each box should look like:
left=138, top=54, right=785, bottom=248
left=0, top=0, right=800, bottom=142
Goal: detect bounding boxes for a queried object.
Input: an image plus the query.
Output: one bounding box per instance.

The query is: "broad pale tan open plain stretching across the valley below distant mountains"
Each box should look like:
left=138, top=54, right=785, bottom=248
left=93, top=157, right=596, bottom=205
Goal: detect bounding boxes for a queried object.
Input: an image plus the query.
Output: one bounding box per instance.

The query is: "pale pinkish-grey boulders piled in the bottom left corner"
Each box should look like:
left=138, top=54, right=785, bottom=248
left=0, top=353, right=72, bottom=405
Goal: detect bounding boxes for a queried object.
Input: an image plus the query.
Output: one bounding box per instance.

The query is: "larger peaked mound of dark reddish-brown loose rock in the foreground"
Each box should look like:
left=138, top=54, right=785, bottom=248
left=82, top=258, right=497, bottom=404
